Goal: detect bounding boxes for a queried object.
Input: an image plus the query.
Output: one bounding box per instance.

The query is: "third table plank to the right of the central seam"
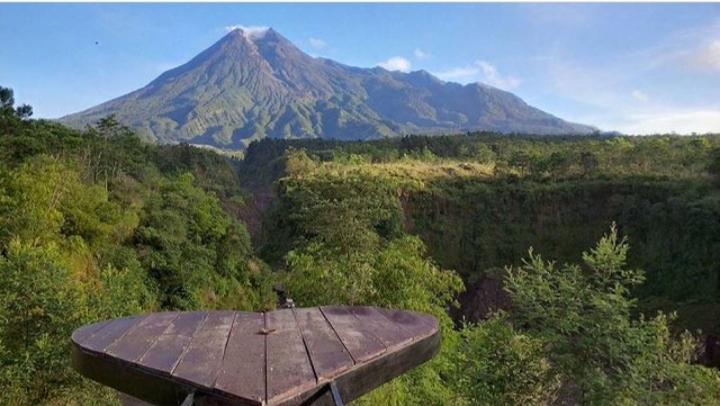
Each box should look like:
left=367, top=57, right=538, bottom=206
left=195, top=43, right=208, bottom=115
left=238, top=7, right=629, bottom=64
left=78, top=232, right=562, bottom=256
left=320, top=306, right=386, bottom=363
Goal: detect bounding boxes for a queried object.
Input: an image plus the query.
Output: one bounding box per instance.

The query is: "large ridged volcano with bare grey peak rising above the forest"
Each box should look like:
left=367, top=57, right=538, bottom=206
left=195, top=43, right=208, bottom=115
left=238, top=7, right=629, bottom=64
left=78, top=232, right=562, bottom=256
left=60, top=28, right=595, bottom=148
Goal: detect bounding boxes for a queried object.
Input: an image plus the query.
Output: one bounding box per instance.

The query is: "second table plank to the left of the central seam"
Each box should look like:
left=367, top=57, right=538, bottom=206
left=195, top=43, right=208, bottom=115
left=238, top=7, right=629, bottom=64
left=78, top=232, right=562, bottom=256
left=172, top=311, right=235, bottom=389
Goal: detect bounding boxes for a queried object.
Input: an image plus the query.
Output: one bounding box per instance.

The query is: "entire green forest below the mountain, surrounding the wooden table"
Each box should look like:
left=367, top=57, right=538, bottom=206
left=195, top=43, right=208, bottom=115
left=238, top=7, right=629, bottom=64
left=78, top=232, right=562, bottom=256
left=0, top=84, right=720, bottom=405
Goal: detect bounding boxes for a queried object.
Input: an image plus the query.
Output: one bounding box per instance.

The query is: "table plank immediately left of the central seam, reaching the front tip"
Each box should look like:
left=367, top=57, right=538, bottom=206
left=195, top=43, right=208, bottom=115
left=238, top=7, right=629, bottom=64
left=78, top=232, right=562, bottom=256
left=215, top=312, right=265, bottom=405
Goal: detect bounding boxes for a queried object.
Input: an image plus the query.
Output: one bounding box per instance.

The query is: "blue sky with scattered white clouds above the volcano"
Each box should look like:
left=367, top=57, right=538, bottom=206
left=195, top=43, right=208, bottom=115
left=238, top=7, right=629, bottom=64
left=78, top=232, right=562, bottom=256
left=0, top=3, right=720, bottom=134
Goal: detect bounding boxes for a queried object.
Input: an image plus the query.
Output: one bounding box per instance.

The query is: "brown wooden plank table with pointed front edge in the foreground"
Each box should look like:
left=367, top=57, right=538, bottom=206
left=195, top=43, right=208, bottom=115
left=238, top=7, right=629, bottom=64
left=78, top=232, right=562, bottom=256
left=72, top=306, right=440, bottom=406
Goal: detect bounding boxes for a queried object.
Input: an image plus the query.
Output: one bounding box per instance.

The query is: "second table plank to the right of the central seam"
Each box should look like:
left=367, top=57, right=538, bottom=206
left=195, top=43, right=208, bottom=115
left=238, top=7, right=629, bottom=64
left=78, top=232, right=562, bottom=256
left=293, top=307, right=354, bottom=382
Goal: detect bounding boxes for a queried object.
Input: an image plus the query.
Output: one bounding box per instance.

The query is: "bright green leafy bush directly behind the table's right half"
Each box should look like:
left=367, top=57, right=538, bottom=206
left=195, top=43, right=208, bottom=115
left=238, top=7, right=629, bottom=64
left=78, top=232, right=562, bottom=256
left=284, top=236, right=462, bottom=405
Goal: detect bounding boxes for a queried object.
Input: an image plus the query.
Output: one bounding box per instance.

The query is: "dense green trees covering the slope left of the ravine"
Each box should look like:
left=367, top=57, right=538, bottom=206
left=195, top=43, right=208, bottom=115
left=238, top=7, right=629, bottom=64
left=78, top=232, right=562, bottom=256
left=0, top=88, right=275, bottom=406
